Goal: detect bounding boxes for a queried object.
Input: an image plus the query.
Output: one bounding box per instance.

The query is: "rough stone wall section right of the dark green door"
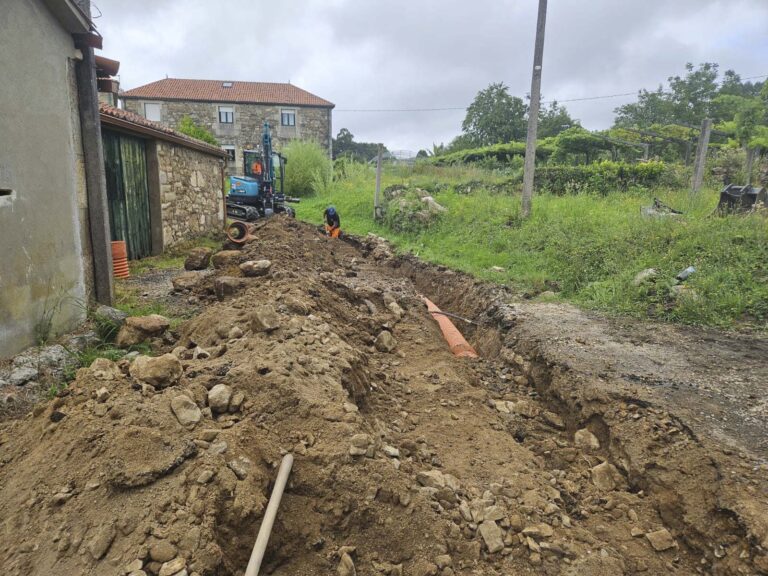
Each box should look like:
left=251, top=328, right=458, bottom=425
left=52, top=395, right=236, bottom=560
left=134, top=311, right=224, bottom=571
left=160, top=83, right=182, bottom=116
left=157, top=140, right=224, bottom=248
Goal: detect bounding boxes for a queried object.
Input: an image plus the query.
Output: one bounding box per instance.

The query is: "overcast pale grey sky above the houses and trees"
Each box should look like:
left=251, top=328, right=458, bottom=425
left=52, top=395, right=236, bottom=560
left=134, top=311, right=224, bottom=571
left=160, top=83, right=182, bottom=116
left=93, top=0, right=768, bottom=151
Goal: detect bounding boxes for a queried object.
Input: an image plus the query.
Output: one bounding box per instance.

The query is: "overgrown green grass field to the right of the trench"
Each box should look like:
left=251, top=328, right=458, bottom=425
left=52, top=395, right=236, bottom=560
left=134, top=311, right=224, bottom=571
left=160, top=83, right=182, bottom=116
left=297, top=165, right=768, bottom=330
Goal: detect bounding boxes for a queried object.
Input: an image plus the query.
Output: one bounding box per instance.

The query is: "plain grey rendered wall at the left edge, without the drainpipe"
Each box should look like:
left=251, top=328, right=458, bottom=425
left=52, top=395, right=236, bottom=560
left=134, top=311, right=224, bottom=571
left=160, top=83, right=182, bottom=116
left=0, top=0, right=91, bottom=357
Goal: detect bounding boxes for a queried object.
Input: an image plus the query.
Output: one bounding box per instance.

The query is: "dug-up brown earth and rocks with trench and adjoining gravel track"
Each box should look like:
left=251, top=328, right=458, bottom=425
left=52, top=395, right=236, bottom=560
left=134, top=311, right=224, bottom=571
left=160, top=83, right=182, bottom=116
left=0, top=218, right=768, bottom=576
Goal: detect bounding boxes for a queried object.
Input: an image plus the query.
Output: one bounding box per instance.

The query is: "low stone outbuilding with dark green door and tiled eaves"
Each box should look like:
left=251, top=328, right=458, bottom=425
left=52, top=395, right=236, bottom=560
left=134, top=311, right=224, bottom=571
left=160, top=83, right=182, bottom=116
left=100, top=102, right=227, bottom=259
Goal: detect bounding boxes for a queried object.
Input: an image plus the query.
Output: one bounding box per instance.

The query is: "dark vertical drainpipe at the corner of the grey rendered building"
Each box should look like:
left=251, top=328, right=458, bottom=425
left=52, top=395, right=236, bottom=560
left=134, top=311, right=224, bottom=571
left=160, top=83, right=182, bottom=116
left=75, top=39, right=114, bottom=305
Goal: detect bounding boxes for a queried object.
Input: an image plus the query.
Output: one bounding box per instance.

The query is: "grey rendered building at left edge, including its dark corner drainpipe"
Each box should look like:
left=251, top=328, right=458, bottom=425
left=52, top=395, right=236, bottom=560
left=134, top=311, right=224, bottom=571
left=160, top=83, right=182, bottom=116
left=0, top=0, right=112, bottom=358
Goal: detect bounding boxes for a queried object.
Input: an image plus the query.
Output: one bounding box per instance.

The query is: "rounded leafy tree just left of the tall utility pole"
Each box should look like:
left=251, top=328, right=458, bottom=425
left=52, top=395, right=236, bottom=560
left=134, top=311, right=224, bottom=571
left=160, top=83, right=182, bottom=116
left=461, top=82, right=528, bottom=146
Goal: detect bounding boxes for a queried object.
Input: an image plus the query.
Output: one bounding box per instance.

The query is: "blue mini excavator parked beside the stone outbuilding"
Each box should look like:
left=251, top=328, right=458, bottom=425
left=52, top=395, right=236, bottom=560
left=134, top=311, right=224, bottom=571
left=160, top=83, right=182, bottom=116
left=227, top=122, right=299, bottom=222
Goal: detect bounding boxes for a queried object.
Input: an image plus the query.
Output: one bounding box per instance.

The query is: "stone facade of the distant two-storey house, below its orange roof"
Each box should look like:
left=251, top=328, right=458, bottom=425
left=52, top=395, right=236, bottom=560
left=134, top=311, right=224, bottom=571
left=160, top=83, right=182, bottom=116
left=124, top=98, right=332, bottom=174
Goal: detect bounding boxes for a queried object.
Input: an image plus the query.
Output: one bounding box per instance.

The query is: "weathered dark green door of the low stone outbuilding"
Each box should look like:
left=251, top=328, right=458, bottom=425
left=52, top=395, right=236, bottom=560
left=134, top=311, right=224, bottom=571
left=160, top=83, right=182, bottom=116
left=102, top=130, right=152, bottom=260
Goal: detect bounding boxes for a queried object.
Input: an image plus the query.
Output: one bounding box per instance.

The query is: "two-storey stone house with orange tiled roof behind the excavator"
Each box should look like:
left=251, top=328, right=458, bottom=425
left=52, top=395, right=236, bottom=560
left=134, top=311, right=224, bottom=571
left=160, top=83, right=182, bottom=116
left=120, top=78, right=334, bottom=174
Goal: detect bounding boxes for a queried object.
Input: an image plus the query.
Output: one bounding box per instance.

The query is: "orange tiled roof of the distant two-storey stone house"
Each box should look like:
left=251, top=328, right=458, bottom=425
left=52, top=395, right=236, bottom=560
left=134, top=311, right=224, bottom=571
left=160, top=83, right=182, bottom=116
left=121, top=78, right=335, bottom=108
